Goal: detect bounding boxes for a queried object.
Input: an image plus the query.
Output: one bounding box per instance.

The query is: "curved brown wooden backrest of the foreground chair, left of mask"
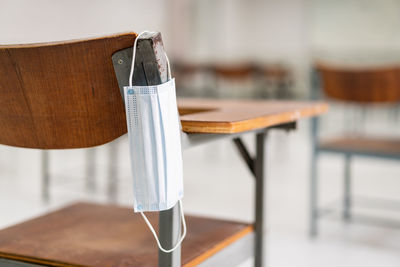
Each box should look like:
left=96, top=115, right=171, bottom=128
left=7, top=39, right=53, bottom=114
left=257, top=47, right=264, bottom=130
left=0, top=33, right=137, bottom=149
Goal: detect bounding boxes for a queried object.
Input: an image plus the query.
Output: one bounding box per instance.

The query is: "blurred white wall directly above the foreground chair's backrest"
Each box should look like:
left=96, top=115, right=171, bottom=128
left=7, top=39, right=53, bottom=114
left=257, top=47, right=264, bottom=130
left=0, top=0, right=167, bottom=44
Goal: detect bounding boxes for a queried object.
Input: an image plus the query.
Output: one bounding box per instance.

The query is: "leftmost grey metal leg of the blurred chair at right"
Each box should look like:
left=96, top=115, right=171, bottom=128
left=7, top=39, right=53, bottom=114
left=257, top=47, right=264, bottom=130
left=309, top=149, right=318, bottom=237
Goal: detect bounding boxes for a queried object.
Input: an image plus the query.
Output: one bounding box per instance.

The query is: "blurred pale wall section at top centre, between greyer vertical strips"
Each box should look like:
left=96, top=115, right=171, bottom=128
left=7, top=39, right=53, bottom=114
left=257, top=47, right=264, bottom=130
left=189, top=0, right=308, bottom=61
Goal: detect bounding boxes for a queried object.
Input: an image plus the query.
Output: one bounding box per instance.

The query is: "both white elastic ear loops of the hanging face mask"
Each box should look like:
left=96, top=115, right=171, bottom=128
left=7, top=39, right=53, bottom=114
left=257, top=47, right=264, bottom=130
left=129, top=31, right=186, bottom=253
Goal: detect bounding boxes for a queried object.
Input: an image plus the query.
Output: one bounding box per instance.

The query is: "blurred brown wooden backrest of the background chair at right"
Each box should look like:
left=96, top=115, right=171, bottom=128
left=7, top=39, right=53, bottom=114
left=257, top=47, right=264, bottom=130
left=316, top=63, right=400, bottom=104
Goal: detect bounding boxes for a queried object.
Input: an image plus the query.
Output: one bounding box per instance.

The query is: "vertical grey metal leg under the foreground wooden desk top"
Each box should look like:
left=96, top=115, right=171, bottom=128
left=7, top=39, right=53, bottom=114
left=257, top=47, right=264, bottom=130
left=254, top=132, right=267, bottom=267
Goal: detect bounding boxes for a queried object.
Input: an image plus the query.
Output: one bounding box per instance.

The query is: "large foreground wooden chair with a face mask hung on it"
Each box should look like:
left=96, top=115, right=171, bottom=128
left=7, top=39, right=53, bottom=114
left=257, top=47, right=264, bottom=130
left=0, top=33, right=253, bottom=266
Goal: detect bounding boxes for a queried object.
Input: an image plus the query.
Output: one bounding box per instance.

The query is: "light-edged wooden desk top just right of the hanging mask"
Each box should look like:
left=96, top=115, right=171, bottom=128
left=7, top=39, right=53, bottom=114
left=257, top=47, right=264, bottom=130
left=178, top=98, right=328, bottom=134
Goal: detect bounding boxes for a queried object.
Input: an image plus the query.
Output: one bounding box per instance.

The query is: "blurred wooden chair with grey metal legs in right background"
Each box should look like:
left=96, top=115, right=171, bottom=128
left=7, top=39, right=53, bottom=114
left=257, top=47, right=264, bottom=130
left=309, top=62, right=400, bottom=236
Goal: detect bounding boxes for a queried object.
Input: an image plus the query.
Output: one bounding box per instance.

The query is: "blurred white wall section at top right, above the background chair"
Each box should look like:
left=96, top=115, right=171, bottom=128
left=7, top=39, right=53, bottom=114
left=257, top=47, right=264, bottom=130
left=310, top=0, right=400, bottom=62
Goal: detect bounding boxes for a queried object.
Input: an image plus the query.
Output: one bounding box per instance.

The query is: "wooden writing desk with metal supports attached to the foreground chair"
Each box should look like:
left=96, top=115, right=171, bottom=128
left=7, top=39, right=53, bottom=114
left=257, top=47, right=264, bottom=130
left=173, top=99, right=328, bottom=267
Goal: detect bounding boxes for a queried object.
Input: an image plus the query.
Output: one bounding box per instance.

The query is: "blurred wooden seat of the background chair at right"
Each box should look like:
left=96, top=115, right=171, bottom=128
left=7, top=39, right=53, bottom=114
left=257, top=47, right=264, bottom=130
left=318, top=137, right=400, bottom=158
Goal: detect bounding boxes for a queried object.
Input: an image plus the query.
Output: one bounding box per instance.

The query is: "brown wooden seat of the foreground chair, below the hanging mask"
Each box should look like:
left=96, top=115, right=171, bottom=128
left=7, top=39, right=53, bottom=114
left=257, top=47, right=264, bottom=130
left=0, top=203, right=253, bottom=267
